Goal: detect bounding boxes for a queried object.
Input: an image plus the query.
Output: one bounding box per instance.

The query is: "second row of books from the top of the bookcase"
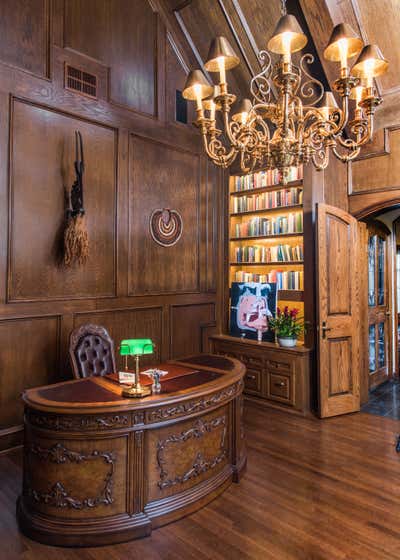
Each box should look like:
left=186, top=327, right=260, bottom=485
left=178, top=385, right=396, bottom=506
left=232, top=187, right=303, bottom=213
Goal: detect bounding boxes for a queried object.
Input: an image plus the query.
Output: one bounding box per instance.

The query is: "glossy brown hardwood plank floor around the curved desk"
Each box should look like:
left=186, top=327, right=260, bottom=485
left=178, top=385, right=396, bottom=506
left=0, top=405, right=400, bottom=560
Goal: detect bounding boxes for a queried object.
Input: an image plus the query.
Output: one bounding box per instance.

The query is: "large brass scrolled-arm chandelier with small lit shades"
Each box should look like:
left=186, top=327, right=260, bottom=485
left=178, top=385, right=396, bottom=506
left=183, top=0, right=388, bottom=184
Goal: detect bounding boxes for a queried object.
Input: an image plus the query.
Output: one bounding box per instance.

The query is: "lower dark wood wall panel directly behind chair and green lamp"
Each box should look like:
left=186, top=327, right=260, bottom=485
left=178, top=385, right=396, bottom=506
left=74, top=307, right=163, bottom=369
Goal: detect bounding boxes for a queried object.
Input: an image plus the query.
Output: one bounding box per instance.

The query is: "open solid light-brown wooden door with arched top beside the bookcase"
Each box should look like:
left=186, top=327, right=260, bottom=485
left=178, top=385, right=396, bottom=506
left=317, top=204, right=360, bottom=418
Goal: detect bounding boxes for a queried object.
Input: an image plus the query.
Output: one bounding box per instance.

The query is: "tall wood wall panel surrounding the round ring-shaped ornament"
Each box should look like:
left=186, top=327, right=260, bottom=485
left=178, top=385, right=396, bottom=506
left=128, top=135, right=200, bottom=295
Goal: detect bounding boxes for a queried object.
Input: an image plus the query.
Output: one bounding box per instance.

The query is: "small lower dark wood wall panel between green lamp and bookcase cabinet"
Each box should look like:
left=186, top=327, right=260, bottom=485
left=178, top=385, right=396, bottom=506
left=170, top=303, right=215, bottom=358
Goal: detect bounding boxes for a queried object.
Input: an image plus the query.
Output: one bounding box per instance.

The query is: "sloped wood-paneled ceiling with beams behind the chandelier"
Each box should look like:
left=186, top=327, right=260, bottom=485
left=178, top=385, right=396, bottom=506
left=164, top=0, right=400, bottom=128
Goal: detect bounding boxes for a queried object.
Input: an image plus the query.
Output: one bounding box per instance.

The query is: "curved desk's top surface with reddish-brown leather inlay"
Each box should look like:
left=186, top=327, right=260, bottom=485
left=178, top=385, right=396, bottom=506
left=23, top=354, right=244, bottom=409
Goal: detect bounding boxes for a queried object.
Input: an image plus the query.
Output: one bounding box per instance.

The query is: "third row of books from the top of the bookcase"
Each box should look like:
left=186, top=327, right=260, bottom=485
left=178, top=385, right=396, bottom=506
left=235, top=212, right=303, bottom=237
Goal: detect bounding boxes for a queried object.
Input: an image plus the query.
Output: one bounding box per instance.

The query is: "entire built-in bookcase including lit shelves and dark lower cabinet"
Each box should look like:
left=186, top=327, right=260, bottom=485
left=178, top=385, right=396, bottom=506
left=210, top=162, right=314, bottom=415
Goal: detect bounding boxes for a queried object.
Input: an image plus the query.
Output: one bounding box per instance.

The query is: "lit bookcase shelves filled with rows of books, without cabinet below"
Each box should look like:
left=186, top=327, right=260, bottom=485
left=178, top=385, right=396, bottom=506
left=229, top=168, right=304, bottom=324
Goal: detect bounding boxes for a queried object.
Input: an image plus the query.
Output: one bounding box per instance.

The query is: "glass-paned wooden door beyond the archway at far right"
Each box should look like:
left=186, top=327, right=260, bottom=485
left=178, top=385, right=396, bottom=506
left=367, top=220, right=391, bottom=389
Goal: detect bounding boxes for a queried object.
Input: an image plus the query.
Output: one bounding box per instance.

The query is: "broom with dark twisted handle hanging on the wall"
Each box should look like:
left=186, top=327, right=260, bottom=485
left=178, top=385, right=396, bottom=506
left=64, top=130, right=89, bottom=266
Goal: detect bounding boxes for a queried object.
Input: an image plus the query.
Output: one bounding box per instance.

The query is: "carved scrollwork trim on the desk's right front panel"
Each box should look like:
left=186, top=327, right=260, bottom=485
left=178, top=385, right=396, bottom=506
left=157, top=416, right=227, bottom=490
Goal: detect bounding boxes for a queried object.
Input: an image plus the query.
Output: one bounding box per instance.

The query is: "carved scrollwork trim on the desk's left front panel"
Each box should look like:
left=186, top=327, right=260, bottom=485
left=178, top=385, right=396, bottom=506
left=27, top=443, right=116, bottom=509
